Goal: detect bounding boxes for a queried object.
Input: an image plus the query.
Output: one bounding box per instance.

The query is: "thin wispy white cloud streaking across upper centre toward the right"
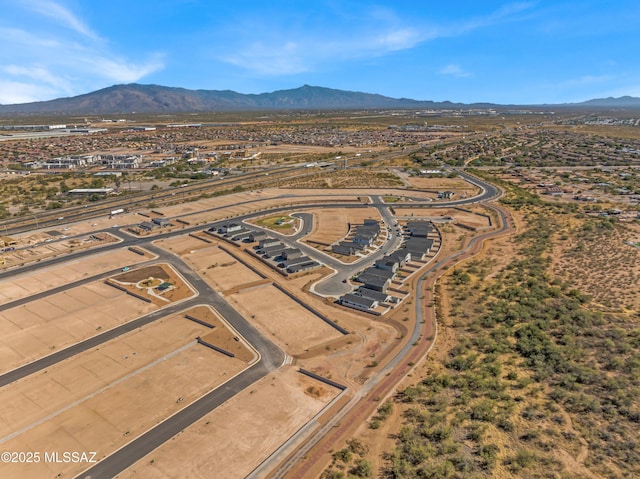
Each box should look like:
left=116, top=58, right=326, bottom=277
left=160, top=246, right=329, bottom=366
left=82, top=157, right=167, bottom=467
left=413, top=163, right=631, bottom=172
left=218, top=2, right=533, bottom=76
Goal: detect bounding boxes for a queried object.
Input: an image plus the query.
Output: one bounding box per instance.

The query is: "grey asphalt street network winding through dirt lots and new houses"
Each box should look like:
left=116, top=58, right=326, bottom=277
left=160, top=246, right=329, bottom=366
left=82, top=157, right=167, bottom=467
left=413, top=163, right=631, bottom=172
left=0, top=171, right=498, bottom=478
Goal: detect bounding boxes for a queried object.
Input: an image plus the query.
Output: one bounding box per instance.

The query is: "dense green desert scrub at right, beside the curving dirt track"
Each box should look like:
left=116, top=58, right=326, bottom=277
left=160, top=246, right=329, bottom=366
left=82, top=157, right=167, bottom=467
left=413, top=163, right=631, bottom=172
left=385, top=191, right=640, bottom=478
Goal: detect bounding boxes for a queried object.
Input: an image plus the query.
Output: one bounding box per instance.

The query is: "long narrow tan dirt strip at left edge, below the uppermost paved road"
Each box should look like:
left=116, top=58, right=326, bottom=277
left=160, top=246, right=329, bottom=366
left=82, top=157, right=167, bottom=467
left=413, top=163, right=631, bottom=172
left=0, top=248, right=153, bottom=304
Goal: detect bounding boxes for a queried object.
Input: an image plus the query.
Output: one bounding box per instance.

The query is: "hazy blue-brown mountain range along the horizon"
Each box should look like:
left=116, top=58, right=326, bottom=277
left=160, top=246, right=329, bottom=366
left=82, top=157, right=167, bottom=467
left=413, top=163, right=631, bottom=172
left=0, top=83, right=640, bottom=115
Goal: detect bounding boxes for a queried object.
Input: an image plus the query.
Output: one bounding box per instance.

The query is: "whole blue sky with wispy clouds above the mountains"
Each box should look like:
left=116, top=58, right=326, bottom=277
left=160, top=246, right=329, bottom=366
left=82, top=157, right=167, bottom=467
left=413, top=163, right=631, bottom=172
left=0, top=0, right=640, bottom=104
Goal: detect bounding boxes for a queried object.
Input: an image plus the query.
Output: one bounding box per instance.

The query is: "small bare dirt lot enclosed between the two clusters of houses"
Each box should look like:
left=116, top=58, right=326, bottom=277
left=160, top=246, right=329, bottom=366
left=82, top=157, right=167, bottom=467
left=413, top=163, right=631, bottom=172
left=305, top=208, right=380, bottom=246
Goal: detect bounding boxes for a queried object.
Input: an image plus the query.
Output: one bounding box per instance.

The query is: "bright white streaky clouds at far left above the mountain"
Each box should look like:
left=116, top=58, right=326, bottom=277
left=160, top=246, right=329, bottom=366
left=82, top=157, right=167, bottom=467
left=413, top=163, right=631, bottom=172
left=0, top=0, right=164, bottom=103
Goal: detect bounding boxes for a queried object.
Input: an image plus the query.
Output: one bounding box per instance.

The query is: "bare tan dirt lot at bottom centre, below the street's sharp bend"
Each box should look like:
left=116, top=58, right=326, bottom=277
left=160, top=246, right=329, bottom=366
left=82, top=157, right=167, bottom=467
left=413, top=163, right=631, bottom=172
left=118, top=366, right=339, bottom=479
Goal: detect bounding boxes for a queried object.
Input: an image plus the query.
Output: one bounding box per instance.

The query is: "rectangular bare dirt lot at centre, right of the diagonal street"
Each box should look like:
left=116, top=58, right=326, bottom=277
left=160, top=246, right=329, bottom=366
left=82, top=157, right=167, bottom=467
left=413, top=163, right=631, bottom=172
left=229, top=285, right=341, bottom=354
